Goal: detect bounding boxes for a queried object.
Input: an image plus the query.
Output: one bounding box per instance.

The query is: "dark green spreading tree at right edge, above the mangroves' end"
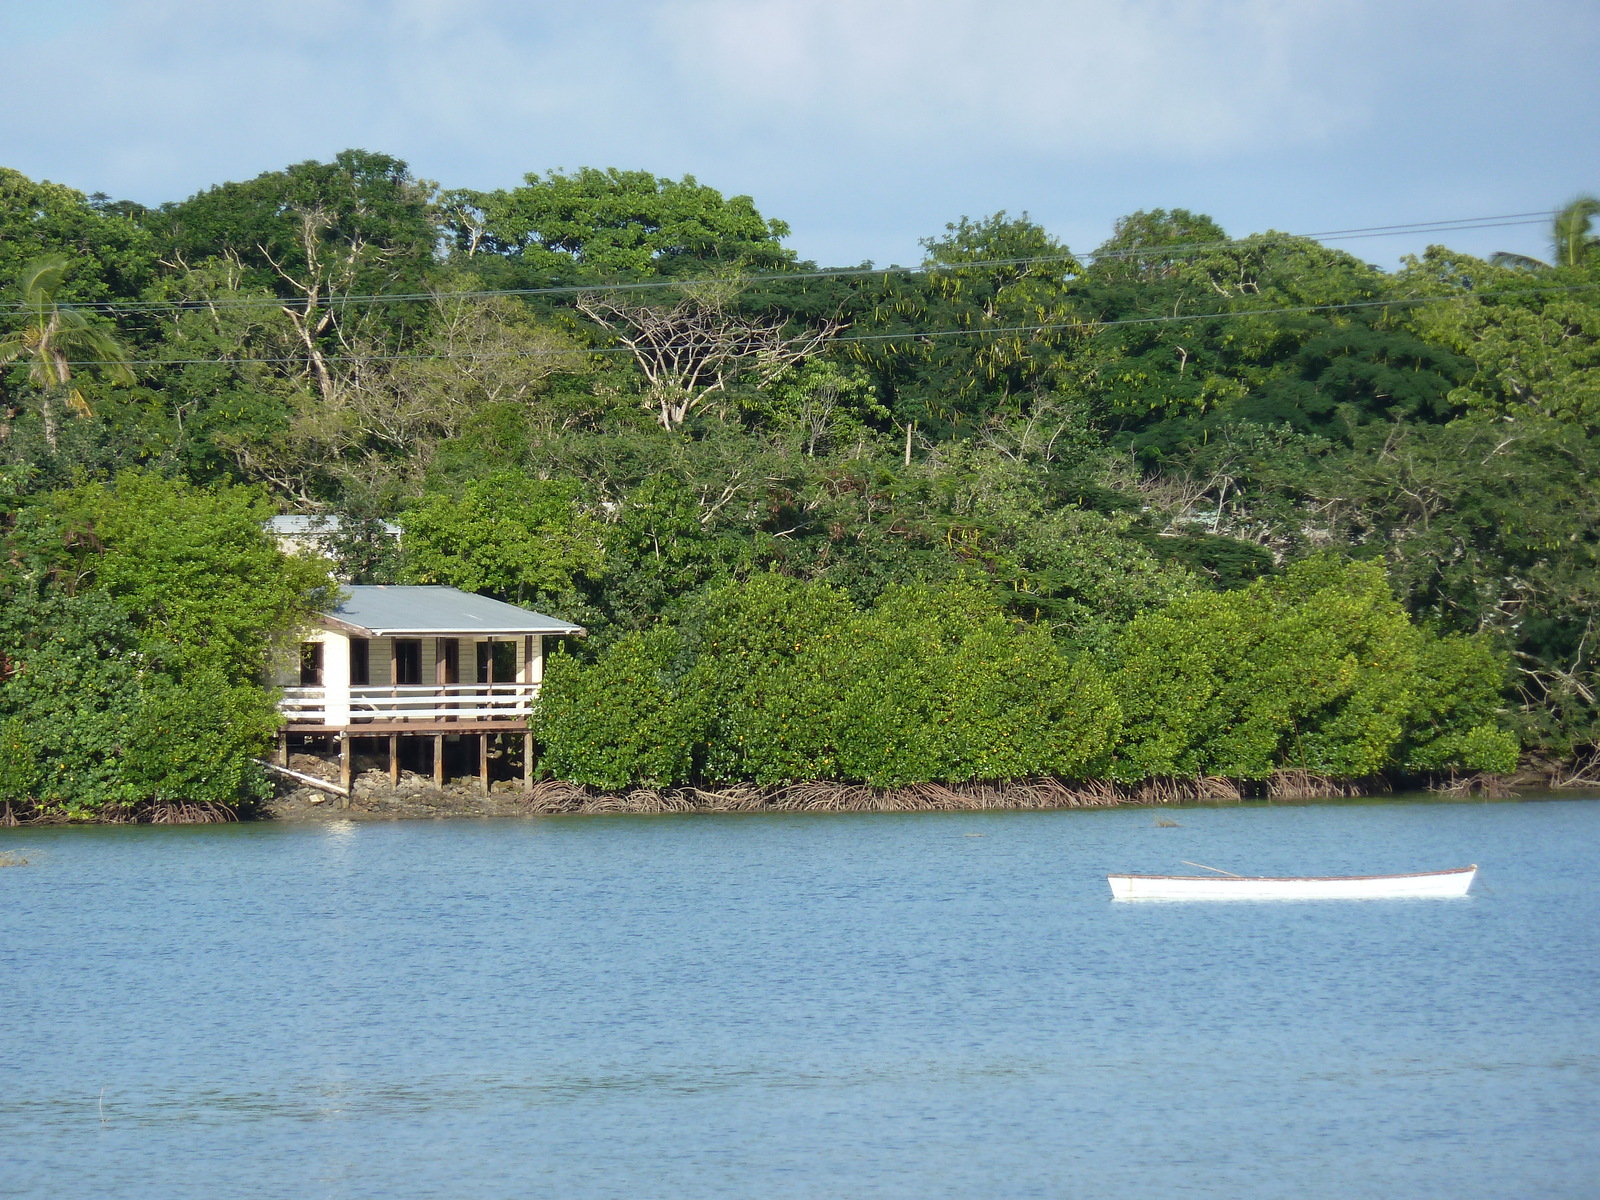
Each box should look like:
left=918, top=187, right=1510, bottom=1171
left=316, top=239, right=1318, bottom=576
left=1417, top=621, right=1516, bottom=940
left=1280, top=418, right=1600, bottom=757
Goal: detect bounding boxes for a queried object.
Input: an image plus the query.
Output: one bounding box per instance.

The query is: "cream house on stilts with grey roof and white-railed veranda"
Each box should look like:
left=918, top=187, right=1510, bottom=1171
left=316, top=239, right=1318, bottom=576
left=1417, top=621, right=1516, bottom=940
left=274, top=586, right=584, bottom=792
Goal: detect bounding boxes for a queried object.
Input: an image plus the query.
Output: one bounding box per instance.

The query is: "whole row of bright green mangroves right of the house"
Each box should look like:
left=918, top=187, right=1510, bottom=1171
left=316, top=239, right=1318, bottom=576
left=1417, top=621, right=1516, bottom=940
left=539, top=569, right=1517, bottom=787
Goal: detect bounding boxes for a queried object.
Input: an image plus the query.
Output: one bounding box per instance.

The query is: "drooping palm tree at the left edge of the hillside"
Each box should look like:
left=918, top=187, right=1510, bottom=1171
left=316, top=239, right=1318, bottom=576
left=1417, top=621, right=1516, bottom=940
left=0, top=254, right=133, bottom=450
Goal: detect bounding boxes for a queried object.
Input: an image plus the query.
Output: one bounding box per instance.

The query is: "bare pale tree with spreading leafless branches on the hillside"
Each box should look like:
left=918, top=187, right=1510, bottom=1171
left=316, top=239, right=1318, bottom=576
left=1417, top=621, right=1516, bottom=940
left=578, top=291, right=846, bottom=429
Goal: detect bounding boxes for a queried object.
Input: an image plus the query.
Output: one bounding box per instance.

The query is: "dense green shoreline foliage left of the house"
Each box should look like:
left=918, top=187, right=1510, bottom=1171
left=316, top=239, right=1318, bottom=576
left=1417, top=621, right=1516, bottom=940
left=0, top=472, right=331, bottom=818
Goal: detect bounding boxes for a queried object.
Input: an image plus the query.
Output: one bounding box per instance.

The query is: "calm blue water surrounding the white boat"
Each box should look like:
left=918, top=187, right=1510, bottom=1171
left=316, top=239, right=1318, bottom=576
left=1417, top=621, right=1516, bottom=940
left=0, top=800, right=1600, bottom=1200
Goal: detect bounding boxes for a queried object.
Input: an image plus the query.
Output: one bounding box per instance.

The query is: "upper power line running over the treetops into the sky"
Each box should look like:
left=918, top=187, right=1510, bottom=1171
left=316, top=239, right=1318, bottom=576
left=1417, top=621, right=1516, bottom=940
left=9, top=210, right=1557, bottom=315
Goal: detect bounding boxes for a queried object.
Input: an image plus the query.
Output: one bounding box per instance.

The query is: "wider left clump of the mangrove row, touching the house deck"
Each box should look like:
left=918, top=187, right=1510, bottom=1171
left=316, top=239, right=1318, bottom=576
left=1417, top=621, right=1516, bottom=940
left=539, top=574, right=1120, bottom=787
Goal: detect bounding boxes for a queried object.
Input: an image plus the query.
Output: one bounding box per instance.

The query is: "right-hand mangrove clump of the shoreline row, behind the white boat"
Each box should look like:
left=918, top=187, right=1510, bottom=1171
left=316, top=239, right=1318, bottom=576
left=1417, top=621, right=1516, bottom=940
left=1115, top=558, right=1517, bottom=781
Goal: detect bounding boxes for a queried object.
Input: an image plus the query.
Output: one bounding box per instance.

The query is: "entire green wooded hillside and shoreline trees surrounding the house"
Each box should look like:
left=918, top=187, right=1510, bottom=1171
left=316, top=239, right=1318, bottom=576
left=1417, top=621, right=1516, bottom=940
left=0, top=150, right=1600, bottom=811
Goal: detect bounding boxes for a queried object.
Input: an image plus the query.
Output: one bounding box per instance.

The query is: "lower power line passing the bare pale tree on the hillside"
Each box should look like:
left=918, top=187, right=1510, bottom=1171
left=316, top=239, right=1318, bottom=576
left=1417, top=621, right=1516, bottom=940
left=53, top=283, right=1600, bottom=374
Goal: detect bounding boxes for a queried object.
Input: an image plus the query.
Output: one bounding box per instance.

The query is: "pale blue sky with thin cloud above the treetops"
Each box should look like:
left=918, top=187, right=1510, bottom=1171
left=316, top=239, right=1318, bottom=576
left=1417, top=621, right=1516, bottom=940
left=0, top=0, right=1600, bottom=266
